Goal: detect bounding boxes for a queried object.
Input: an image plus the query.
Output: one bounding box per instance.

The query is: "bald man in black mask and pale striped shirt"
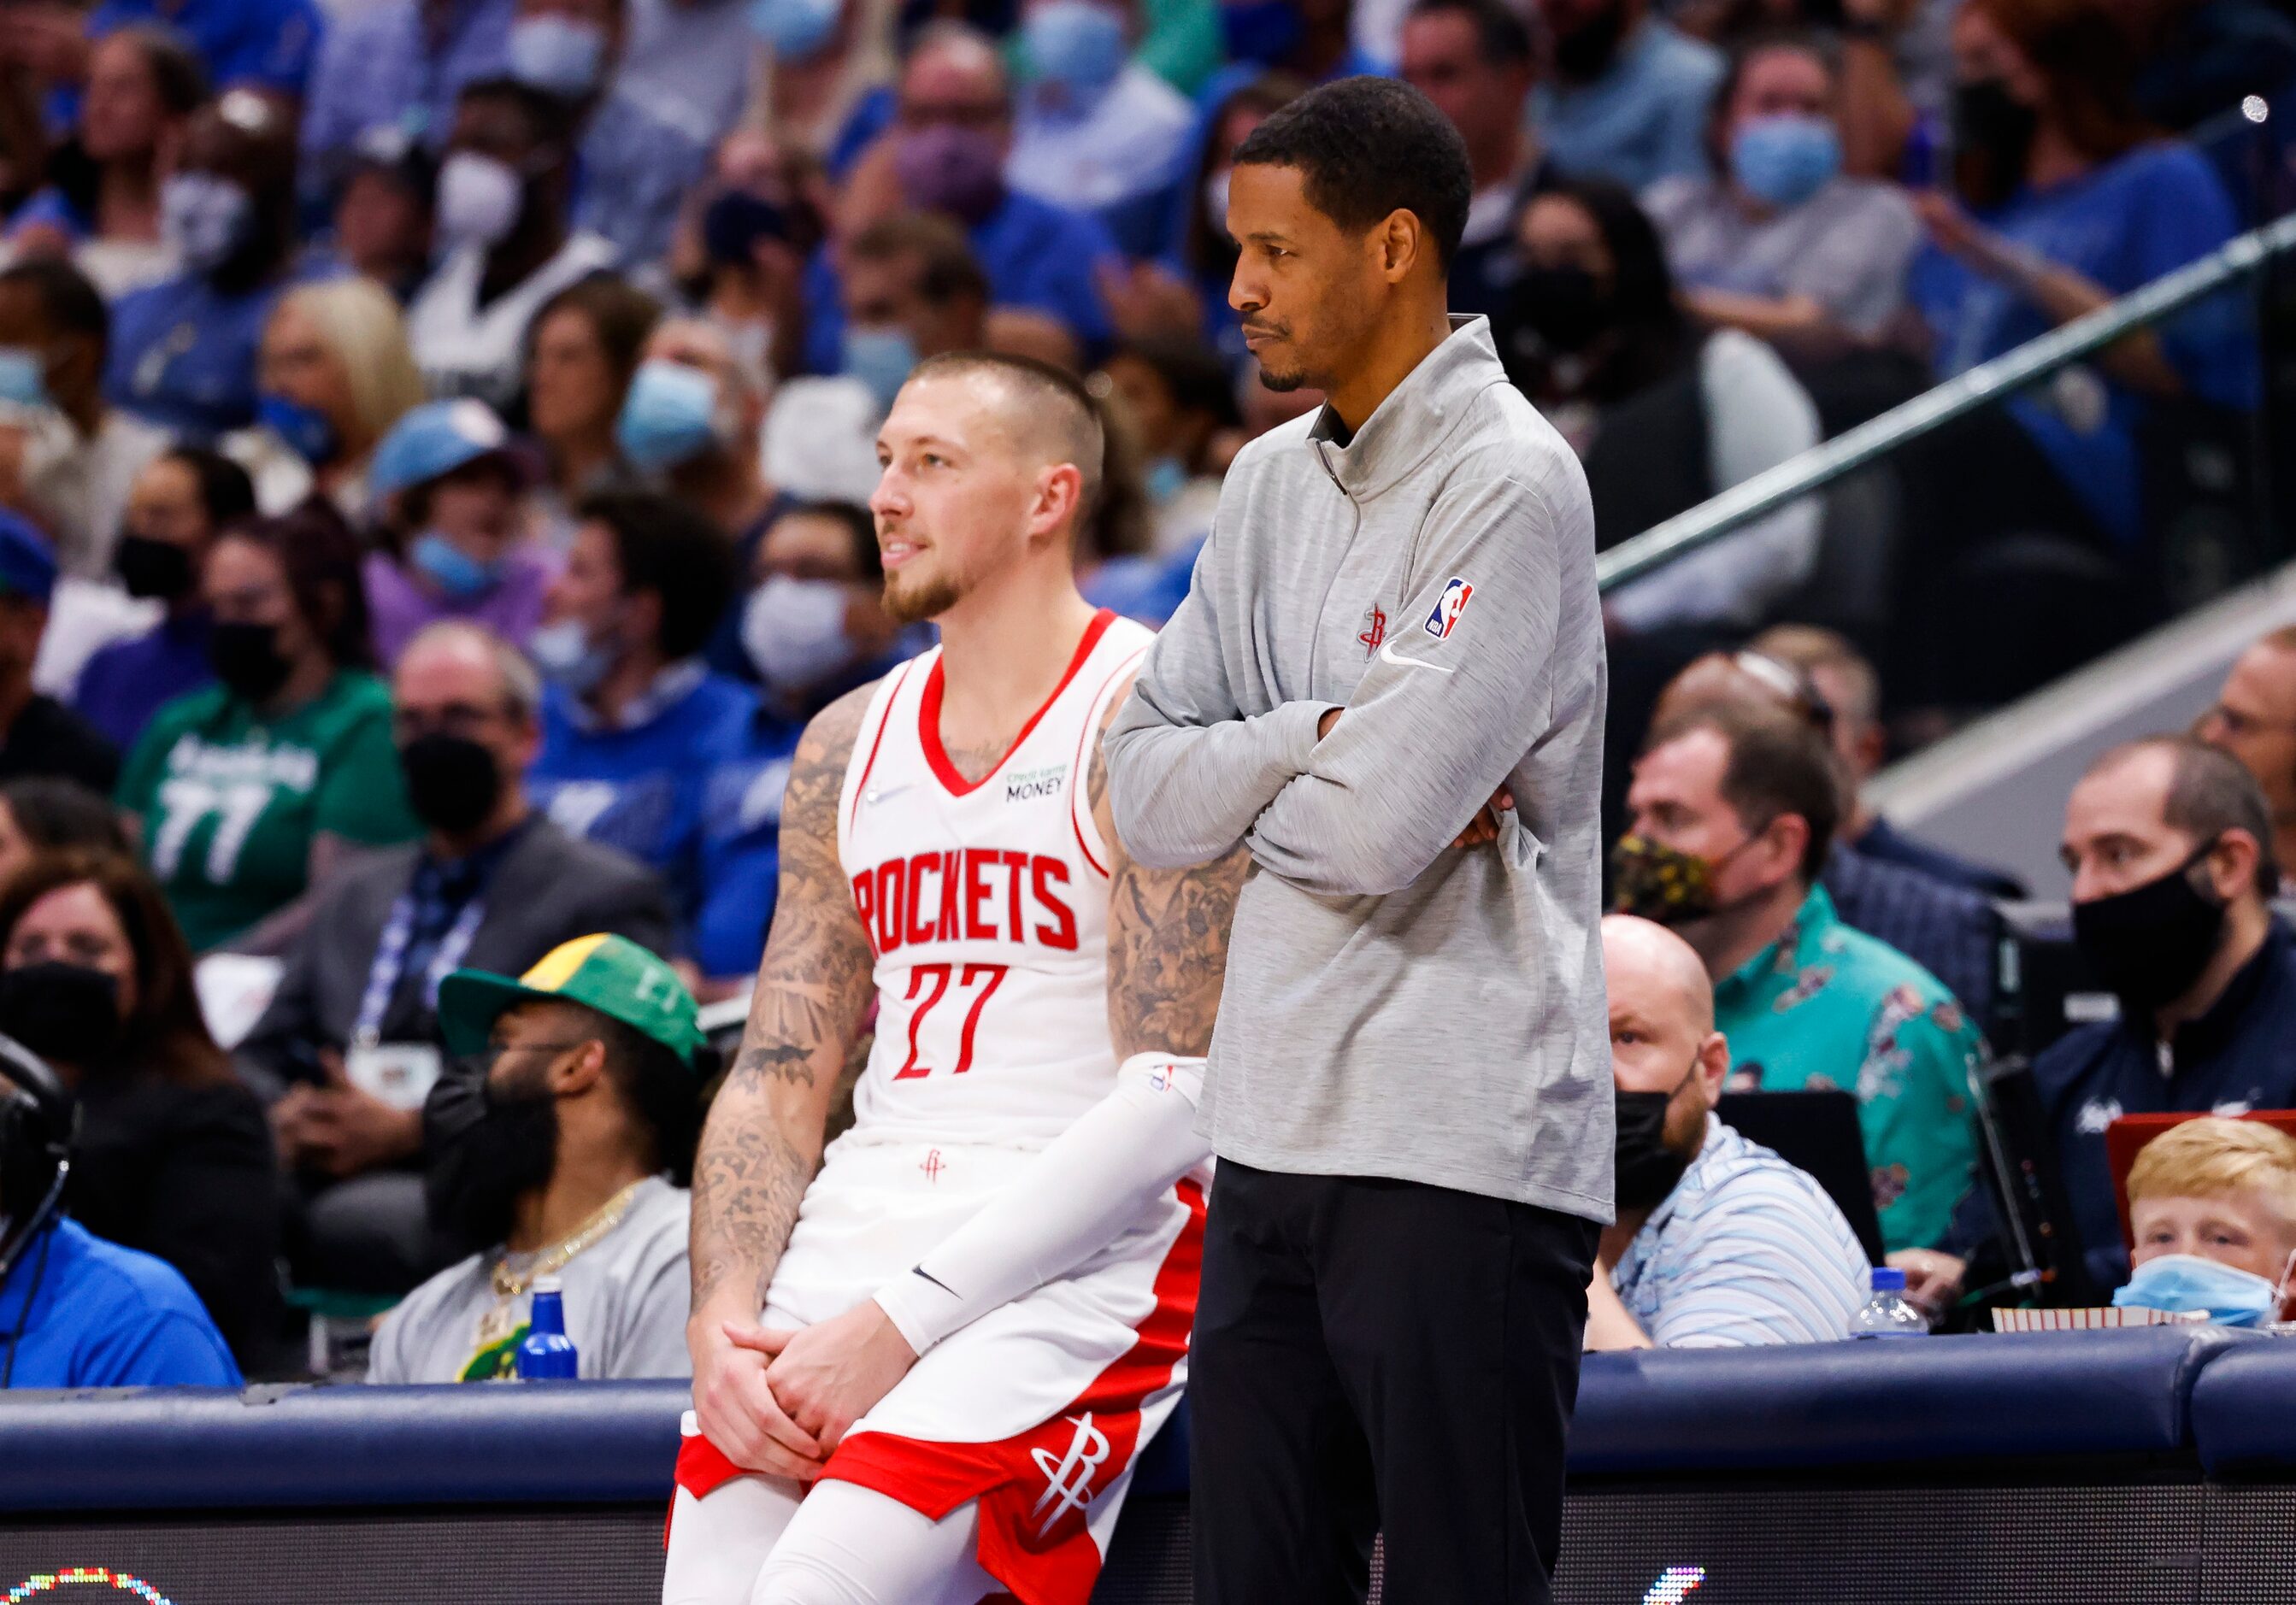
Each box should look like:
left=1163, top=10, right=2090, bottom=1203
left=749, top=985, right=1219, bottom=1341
left=1587, top=914, right=1871, bottom=1348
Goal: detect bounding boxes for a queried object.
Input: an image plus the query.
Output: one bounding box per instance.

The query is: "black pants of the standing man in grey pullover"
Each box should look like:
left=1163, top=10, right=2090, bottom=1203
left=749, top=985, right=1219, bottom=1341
left=1187, top=1160, right=1598, bottom=1605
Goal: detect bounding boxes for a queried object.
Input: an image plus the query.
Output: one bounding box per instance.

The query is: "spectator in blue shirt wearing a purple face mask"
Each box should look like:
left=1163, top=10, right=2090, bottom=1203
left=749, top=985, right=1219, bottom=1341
left=806, top=23, right=1116, bottom=374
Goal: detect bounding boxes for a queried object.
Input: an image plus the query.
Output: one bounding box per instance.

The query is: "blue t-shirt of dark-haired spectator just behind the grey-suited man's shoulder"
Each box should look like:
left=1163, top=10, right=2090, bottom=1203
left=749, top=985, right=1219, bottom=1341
left=528, top=661, right=757, bottom=939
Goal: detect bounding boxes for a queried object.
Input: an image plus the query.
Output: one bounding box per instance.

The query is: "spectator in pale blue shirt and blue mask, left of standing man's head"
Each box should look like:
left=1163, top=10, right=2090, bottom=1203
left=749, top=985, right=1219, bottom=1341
left=1004, top=0, right=1196, bottom=220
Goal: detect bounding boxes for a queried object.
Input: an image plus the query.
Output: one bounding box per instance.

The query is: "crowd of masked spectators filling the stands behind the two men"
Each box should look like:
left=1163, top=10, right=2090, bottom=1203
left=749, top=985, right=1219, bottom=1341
left=0, top=0, right=2296, bottom=1378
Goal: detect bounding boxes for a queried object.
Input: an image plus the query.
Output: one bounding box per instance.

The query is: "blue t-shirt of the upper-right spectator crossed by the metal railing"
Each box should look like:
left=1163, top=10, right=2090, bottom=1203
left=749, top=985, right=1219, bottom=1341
left=1905, top=140, right=2262, bottom=544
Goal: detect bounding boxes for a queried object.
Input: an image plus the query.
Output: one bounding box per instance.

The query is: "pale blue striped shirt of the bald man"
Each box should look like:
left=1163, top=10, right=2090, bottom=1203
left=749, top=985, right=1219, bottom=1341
left=1610, top=1114, right=1874, bottom=1348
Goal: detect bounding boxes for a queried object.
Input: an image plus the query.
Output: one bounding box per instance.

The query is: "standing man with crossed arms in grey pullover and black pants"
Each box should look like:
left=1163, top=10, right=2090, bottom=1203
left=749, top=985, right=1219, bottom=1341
left=1107, top=78, right=1616, bottom=1605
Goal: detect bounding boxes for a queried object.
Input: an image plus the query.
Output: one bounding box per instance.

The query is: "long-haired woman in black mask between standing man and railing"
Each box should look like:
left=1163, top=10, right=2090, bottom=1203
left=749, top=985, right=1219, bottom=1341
left=1495, top=181, right=1821, bottom=632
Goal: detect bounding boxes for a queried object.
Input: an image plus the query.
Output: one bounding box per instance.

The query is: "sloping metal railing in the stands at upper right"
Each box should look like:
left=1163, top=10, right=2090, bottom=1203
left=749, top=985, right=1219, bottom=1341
left=1596, top=214, right=2296, bottom=592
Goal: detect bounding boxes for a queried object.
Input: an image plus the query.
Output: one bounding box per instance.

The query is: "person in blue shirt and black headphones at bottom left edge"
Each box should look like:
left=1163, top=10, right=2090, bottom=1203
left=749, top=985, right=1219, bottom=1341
left=0, top=1043, right=241, bottom=1389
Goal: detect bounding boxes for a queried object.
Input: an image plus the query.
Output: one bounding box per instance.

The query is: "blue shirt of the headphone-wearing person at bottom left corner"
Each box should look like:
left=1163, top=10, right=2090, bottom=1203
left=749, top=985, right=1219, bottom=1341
left=0, top=1220, right=241, bottom=1387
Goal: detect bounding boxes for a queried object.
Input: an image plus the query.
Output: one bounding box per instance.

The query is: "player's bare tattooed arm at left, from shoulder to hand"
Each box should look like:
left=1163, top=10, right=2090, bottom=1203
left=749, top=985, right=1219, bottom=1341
left=686, top=686, right=873, bottom=1477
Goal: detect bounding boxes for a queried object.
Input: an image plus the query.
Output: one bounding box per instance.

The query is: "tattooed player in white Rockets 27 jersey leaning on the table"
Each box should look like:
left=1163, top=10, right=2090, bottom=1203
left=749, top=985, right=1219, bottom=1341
left=663, top=356, right=1239, bottom=1605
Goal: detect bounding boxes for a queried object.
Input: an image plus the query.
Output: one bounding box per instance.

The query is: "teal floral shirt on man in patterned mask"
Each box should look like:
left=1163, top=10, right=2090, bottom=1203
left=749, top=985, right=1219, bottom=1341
left=1715, top=886, right=1986, bottom=1251
